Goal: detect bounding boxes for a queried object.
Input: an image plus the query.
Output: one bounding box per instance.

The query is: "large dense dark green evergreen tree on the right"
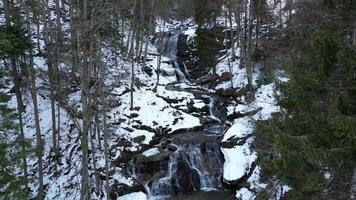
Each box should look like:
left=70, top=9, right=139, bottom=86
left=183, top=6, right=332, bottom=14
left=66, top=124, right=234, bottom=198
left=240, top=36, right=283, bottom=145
left=257, top=1, right=356, bottom=199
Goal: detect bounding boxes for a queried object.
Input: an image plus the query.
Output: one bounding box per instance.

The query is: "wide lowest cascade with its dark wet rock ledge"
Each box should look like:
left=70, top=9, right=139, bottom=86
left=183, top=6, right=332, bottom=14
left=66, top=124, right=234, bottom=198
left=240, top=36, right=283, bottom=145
left=133, top=138, right=223, bottom=200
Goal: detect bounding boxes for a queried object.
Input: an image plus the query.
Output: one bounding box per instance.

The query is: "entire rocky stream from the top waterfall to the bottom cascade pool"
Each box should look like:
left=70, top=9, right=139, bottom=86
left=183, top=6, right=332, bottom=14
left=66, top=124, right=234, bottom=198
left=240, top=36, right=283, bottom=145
left=132, top=32, right=233, bottom=200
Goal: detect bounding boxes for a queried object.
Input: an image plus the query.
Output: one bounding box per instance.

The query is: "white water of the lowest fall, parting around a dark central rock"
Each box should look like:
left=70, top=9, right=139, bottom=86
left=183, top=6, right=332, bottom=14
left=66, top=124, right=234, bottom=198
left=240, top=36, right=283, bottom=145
left=145, top=144, right=223, bottom=200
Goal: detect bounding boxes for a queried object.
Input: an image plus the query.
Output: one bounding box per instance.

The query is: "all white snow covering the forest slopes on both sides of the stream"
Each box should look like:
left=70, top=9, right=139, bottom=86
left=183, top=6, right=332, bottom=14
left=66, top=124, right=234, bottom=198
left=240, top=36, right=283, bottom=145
left=2, top=9, right=287, bottom=200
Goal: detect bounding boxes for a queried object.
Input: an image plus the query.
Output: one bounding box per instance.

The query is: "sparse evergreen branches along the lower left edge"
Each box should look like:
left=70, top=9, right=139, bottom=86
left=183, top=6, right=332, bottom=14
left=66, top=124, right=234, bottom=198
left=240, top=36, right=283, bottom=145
left=0, top=69, right=27, bottom=199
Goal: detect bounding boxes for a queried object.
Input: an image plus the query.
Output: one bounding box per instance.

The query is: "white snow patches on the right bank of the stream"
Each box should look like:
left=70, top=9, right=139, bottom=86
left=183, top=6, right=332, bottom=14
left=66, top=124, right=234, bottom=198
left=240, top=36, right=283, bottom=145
left=216, top=49, right=288, bottom=200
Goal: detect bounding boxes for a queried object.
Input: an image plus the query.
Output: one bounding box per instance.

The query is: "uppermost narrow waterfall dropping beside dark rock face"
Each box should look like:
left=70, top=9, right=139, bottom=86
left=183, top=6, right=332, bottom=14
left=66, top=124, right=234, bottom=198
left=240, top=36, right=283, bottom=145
left=156, top=32, right=189, bottom=83
